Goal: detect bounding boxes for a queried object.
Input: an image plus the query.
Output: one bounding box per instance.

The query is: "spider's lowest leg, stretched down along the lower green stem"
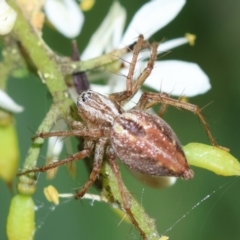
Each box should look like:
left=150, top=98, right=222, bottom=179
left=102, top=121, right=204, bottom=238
left=108, top=155, right=146, bottom=239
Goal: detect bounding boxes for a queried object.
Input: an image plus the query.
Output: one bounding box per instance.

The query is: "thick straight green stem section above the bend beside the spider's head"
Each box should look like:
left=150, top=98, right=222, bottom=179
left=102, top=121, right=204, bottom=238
left=8, top=0, right=67, bottom=102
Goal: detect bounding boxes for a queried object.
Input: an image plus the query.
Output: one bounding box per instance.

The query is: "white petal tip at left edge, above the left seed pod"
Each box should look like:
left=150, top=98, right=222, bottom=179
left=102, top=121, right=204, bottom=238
left=0, top=89, right=24, bottom=113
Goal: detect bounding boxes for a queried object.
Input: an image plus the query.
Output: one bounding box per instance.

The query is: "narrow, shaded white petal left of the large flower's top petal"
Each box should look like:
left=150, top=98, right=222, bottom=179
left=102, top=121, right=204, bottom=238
left=81, top=1, right=126, bottom=60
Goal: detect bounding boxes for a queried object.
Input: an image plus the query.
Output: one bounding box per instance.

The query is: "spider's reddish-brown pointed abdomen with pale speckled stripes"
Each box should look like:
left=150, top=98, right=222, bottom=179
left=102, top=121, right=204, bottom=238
left=111, top=110, right=193, bottom=179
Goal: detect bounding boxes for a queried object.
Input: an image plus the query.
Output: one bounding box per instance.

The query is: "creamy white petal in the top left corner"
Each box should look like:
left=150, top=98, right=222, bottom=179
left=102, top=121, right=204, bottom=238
left=0, top=0, right=17, bottom=35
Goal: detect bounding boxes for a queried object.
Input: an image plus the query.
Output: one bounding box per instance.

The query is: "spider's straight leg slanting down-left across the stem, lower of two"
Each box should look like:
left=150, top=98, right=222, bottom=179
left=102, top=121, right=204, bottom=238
left=17, top=149, right=91, bottom=176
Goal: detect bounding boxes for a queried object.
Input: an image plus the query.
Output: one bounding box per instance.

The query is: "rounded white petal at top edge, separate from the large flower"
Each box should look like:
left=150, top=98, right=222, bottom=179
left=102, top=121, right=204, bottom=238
left=44, top=0, right=84, bottom=38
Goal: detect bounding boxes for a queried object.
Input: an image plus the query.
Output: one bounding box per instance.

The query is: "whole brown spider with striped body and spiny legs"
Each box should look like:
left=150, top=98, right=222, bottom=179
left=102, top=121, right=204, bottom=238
left=19, top=35, right=221, bottom=237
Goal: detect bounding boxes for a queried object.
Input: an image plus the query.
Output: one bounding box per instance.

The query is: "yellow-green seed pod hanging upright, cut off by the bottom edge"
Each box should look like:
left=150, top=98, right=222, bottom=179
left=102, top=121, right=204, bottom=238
left=7, top=194, right=35, bottom=240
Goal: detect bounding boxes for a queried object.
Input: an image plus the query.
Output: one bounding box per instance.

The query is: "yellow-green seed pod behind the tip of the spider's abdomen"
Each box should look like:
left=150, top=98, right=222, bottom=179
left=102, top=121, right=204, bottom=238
left=183, top=143, right=240, bottom=176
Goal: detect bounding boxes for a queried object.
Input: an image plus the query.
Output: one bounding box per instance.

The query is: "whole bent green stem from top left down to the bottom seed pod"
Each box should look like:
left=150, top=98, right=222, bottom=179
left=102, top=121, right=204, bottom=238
left=8, top=0, right=73, bottom=194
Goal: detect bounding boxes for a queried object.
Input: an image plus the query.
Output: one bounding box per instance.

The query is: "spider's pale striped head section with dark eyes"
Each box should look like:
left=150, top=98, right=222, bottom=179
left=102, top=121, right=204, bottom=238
left=77, top=90, right=123, bottom=126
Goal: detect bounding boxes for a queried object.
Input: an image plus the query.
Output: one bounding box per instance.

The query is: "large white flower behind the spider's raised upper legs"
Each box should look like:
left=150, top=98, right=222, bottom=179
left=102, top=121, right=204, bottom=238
left=81, top=0, right=211, bottom=107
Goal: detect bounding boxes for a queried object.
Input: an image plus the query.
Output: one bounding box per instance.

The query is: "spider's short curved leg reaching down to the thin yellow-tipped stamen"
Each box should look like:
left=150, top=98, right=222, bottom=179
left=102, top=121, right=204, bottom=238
left=75, top=138, right=107, bottom=199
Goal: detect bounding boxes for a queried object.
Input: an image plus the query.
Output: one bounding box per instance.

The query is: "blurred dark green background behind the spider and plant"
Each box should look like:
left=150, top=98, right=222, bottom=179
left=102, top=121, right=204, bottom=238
left=0, top=0, right=240, bottom=240
